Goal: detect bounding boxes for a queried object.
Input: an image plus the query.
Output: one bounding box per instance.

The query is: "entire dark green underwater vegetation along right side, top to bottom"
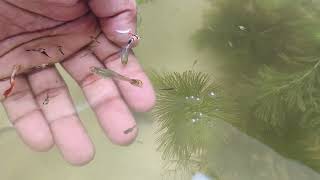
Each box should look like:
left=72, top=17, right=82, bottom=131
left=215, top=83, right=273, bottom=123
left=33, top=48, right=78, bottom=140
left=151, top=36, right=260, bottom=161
left=190, top=0, right=320, bottom=175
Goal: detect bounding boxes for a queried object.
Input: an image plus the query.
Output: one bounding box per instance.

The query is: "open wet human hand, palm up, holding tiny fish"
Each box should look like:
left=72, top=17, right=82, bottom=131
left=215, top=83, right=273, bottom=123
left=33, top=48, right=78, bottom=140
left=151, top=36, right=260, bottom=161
left=0, top=0, right=155, bottom=165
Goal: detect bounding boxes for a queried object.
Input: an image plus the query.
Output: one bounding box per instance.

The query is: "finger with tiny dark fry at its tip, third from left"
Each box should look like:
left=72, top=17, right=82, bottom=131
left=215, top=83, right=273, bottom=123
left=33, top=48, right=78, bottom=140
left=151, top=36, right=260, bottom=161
left=62, top=52, right=138, bottom=145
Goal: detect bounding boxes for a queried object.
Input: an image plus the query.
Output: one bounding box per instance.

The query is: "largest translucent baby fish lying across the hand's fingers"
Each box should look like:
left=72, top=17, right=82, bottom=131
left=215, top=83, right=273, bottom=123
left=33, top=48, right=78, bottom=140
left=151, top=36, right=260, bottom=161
left=90, top=67, right=143, bottom=87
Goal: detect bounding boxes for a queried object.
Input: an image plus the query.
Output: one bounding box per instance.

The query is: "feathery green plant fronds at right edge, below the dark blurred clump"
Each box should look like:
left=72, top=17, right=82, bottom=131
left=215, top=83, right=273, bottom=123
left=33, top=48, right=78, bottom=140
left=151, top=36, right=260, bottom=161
left=254, top=60, right=320, bottom=127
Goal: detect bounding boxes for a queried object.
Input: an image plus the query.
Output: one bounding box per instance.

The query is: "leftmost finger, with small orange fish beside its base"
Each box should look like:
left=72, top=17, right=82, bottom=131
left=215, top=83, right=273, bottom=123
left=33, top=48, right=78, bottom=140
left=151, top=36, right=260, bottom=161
left=0, top=76, right=53, bottom=151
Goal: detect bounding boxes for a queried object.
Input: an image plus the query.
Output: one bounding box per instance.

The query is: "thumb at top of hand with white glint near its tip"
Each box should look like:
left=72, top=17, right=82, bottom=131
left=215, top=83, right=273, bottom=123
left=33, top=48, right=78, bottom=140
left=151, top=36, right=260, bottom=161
left=89, top=0, right=137, bottom=46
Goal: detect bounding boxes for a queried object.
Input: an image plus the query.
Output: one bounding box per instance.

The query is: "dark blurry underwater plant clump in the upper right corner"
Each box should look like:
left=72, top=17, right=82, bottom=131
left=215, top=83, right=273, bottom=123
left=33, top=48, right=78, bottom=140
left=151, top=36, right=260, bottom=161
left=194, top=0, right=320, bottom=70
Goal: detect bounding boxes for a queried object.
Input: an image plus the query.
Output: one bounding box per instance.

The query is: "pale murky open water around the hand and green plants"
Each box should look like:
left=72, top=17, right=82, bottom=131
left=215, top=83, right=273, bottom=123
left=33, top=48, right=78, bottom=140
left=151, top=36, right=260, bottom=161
left=0, top=0, right=320, bottom=180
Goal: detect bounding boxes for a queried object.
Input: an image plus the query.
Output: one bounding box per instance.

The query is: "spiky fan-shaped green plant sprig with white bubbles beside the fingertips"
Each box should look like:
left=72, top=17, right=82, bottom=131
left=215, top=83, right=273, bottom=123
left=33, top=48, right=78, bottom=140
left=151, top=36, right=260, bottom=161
left=151, top=71, right=238, bottom=177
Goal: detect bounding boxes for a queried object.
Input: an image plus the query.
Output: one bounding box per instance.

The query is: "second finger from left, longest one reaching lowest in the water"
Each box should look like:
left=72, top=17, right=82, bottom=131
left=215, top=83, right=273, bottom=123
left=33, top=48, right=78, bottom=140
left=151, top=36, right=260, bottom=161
left=28, top=68, right=94, bottom=165
